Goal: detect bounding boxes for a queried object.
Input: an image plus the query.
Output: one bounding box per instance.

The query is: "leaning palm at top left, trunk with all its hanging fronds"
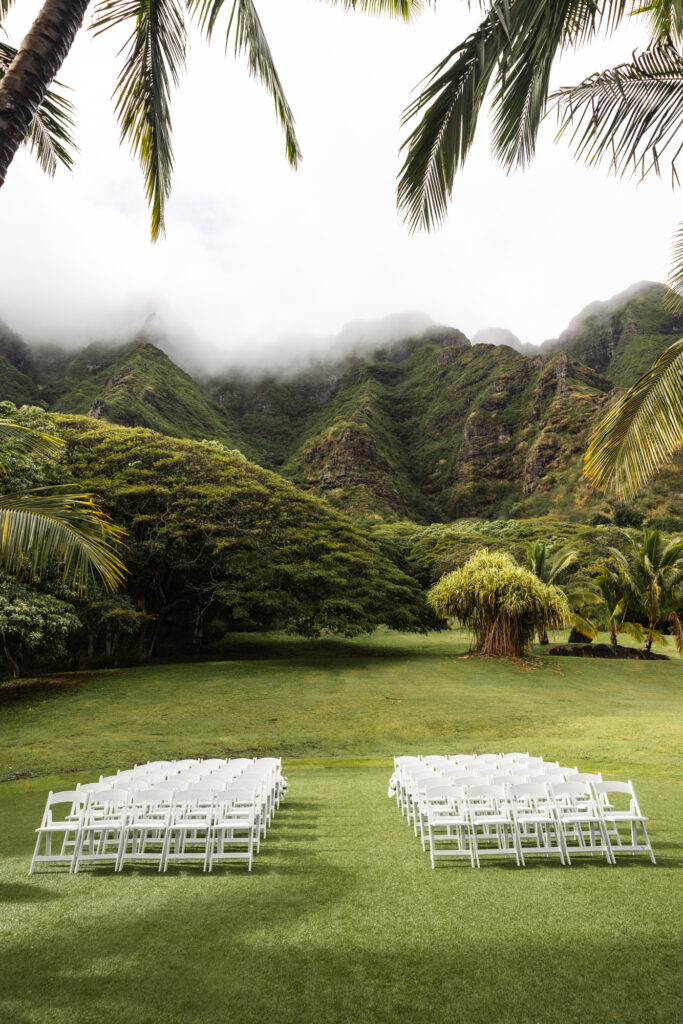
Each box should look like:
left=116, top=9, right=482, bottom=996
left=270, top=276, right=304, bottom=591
left=0, top=0, right=422, bottom=240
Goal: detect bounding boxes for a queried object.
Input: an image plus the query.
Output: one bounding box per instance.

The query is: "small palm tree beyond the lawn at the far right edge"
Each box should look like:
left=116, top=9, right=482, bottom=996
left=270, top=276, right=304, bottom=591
left=609, top=528, right=683, bottom=656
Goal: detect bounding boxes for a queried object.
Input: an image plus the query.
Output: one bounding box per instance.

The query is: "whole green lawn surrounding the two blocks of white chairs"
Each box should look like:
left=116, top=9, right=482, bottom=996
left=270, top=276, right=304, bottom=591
left=0, top=634, right=683, bottom=1024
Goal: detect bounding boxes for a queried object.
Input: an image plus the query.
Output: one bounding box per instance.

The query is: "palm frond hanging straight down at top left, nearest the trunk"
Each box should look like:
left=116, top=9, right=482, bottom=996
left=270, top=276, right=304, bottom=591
left=93, top=0, right=186, bottom=241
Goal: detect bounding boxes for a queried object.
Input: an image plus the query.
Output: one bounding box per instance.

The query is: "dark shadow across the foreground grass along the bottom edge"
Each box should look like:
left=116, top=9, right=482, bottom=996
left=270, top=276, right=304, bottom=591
left=0, top=905, right=683, bottom=1024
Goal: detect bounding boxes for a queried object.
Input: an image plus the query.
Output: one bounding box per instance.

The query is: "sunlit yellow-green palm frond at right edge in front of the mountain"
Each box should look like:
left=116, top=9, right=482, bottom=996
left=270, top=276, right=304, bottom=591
left=584, top=339, right=683, bottom=497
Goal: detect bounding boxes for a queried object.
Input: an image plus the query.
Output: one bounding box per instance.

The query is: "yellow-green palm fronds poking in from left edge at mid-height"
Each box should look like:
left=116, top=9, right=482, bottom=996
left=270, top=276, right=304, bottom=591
left=0, top=420, right=126, bottom=592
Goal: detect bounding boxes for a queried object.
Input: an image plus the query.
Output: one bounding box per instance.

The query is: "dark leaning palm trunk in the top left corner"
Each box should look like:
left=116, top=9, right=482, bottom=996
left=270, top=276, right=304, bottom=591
left=0, top=0, right=89, bottom=186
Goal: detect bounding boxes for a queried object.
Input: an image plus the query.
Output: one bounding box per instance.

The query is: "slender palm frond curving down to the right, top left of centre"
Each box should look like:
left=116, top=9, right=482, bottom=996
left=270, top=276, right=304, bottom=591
left=188, top=0, right=302, bottom=168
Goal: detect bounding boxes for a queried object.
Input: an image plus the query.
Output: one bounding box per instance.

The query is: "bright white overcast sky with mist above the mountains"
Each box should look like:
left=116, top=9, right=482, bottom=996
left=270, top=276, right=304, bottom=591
left=0, top=0, right=681, bottom=361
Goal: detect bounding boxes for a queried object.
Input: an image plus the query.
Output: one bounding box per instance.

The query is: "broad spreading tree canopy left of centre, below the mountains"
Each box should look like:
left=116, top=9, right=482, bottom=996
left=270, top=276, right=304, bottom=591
left=61, top=419, right=432, bottom=652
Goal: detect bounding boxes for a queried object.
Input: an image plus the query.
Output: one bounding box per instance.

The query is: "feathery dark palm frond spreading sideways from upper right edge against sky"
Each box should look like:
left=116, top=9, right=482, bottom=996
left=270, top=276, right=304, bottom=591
left=552, top=44, right=683, bottom=183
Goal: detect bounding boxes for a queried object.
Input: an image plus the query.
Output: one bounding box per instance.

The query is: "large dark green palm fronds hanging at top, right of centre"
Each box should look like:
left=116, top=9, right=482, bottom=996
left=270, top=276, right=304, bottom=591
left=397, top=0, right=631, bottom=230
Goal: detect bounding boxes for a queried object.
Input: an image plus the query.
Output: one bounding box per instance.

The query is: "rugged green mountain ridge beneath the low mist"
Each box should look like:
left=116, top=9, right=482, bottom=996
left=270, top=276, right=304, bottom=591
left=0, top=283, right=683, bottom=522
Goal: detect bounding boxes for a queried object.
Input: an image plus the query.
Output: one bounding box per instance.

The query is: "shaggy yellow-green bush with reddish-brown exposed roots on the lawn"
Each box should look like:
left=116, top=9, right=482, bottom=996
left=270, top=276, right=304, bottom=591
left=429, top=549, right=569, bottom=657
